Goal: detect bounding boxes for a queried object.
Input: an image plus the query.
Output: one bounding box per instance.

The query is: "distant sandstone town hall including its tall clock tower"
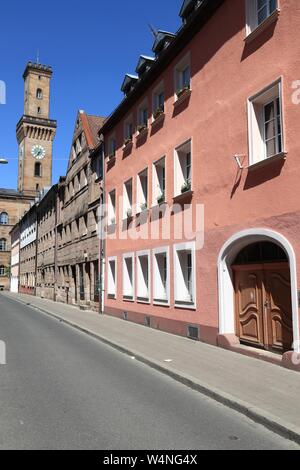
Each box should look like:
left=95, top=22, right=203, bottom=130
left=0, top=62, right=56, bottom=289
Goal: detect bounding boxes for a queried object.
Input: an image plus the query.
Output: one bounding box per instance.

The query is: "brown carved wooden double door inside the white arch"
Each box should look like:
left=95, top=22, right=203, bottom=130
left=233, top=263, right=293, bottom=353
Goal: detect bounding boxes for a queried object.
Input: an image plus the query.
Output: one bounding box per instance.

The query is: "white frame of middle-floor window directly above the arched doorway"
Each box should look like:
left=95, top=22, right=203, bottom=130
left=248, top=77, right=286, bottom=166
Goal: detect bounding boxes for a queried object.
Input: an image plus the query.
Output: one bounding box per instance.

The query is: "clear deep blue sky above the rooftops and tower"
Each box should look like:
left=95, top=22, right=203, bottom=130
left=0, top=0, right=182, bottom=188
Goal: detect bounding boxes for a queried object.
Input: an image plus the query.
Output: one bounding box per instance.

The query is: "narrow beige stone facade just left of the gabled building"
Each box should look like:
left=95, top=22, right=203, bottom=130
left=36, top=184, right=58, bottom=300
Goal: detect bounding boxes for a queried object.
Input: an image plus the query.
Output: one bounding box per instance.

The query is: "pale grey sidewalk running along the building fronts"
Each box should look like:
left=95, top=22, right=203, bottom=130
left=3, top=293, right=300, bottom=444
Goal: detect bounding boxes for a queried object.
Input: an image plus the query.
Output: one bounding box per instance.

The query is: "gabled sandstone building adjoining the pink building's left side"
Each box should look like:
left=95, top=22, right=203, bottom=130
left=57, top=111, right=104, bottom=310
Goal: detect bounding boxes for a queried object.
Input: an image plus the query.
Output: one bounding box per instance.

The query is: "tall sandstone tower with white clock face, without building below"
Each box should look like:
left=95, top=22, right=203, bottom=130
left=17, top=62, right=57, bottom=198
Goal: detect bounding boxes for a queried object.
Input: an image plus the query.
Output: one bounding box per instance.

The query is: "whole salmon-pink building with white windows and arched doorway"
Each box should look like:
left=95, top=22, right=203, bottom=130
left=101, top=0, right=300, bottom=367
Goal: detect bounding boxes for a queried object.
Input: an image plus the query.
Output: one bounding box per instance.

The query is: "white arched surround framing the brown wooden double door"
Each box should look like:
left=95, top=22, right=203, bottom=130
left=218, top=228, right=300, bottom=352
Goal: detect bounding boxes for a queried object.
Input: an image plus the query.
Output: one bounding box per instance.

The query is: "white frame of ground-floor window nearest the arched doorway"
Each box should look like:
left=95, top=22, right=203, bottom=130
left=173, top=242, right=197, bottom=310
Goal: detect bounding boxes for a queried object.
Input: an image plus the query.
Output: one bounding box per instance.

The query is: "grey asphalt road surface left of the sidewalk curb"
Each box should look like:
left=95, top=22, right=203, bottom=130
left=0, top=294, right=299, bottom=450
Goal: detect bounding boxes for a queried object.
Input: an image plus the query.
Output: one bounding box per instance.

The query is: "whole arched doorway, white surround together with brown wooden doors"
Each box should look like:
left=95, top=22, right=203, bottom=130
left=218, top=229, right=299, bottom=353
